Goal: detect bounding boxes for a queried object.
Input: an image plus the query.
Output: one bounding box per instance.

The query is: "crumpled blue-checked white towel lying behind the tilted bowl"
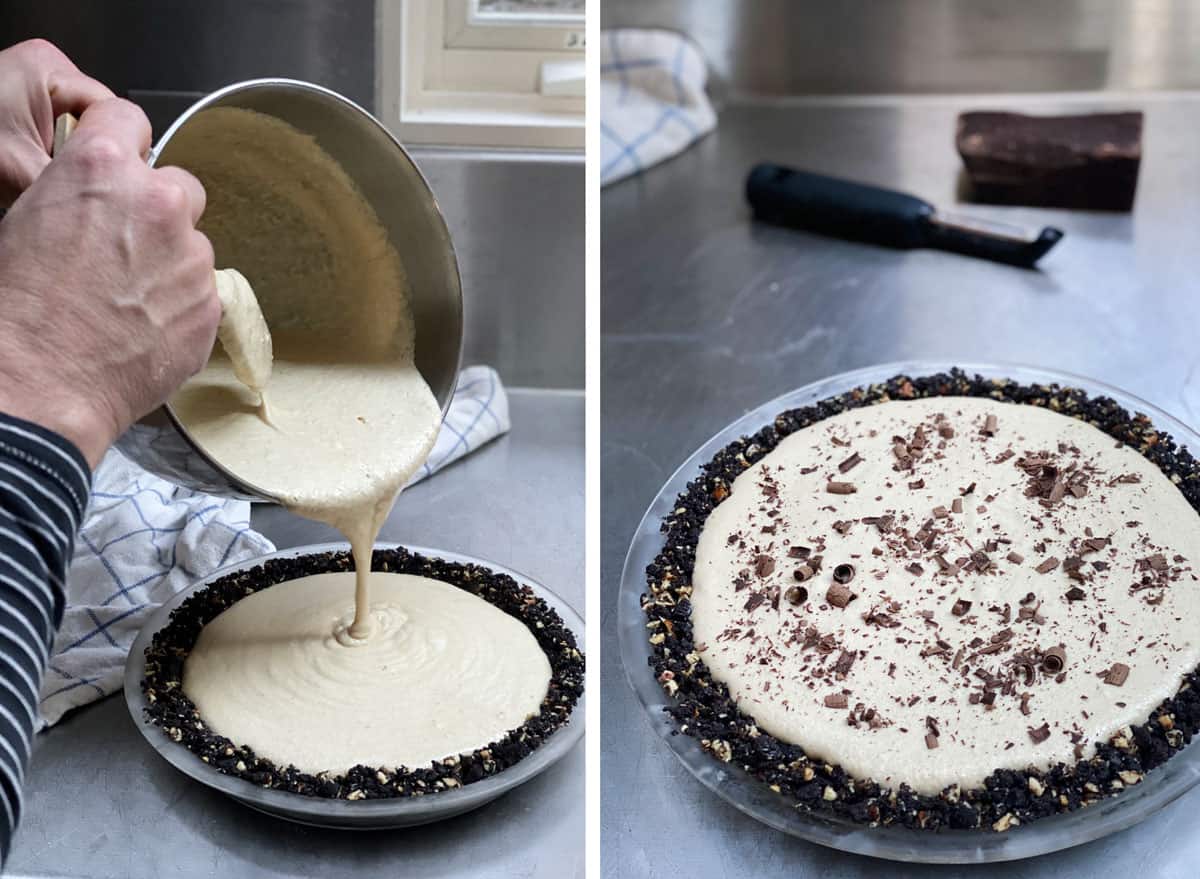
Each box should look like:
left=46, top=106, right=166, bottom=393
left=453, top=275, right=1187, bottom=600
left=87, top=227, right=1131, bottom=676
left=41, top=366, right=510, bottom=726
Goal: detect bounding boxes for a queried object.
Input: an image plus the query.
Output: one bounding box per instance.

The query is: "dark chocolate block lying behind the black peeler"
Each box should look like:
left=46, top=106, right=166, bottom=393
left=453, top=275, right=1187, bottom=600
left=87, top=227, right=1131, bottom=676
left=955, top=113, right=1142, bottom=210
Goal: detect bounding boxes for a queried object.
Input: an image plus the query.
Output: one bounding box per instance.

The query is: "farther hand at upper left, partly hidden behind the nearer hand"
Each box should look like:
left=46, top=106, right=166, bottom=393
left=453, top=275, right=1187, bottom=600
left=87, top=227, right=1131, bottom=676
left=0, top=40, right=113, bottom=205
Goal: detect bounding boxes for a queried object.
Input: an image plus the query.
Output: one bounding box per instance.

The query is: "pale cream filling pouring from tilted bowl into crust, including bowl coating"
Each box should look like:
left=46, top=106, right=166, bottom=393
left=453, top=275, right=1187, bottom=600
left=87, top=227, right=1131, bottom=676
left=163, top=108, right=550, bottom=772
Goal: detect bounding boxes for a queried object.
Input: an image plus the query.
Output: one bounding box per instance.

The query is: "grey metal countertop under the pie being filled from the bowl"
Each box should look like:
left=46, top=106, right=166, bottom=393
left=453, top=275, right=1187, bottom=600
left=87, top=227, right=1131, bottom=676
left=5, top=390, right=584, bottom=879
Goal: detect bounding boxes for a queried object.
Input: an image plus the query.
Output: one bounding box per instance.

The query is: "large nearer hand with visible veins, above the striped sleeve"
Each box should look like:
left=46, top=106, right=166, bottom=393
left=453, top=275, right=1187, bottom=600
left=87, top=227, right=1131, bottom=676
left=0, top=98, right=221, bottom=467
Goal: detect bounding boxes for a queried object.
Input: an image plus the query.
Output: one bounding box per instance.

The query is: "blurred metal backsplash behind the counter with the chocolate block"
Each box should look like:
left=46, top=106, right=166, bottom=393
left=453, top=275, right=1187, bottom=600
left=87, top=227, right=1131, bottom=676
left=601, top=0, right=1200, bottom=95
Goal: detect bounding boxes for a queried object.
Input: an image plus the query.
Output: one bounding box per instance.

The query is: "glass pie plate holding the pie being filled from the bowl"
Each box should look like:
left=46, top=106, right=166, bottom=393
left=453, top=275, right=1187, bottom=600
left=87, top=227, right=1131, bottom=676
left=125, top=543, right=587, bottom=830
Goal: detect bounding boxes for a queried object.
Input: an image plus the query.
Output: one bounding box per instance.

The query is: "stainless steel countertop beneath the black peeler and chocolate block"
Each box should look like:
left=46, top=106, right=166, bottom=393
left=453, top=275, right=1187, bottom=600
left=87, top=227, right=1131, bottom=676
left=601, top=94, right=1200, bottom=879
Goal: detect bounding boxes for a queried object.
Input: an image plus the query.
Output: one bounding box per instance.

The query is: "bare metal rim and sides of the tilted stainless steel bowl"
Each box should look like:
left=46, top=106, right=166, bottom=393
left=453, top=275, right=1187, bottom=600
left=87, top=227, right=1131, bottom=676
left=116, top=79, right=463, bottom=501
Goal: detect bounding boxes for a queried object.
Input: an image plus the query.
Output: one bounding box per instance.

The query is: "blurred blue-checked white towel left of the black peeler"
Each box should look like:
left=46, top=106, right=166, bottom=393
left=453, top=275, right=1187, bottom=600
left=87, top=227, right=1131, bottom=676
left=600, top=30, right=716, bottom=186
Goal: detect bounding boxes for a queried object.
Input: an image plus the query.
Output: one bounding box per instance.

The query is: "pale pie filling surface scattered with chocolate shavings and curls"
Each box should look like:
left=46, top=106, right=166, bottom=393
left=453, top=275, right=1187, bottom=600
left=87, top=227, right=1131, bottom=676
left=691, top=397, right=1200, bottom=794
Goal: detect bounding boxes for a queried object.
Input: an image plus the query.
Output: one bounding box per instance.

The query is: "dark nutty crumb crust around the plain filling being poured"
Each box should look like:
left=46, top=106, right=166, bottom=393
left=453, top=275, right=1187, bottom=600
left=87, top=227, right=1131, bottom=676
left=142, top=548, right=584, bottom=800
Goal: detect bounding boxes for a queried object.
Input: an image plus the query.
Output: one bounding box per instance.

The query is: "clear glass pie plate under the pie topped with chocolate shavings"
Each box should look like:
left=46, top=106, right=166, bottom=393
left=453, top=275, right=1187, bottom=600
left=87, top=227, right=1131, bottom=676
left=617, top=360, right=1200, bottom=863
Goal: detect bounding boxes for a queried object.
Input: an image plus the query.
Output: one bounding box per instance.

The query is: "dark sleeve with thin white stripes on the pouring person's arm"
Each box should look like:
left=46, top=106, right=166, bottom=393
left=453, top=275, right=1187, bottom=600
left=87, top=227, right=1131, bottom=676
left=0, top=414, right=91, bottom=863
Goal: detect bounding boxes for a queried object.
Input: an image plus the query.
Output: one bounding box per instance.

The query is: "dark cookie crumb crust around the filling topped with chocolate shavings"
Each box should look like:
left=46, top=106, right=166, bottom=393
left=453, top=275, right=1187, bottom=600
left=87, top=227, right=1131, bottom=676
left=641, top=370, right=1200, bottom=832
